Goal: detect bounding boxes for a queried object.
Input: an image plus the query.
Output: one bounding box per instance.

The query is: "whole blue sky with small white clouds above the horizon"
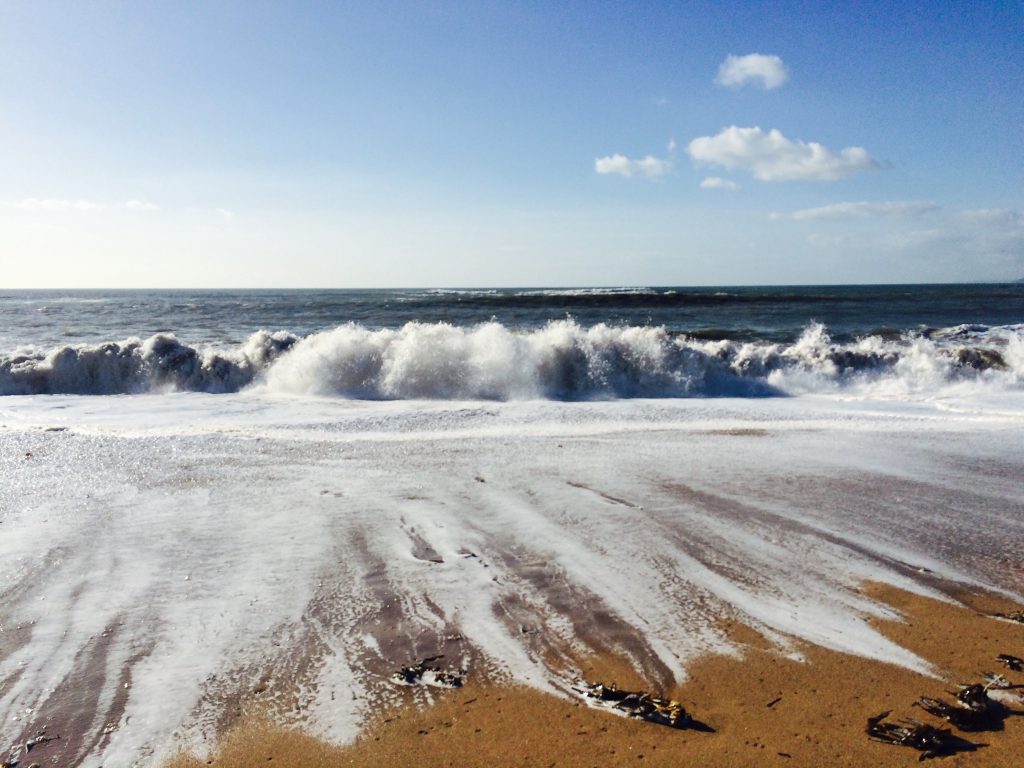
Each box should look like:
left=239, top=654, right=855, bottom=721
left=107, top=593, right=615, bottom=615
left=0, top=0, right=1024, bottom=289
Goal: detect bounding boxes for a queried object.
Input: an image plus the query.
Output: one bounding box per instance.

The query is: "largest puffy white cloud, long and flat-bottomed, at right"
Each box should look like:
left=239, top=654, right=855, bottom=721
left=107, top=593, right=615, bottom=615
left=686, top=125, right=879, bottom=181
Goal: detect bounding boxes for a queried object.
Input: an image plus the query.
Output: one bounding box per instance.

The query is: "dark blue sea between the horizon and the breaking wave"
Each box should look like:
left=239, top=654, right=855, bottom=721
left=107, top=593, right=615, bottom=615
left=0, top=284, right=1024, bottom=351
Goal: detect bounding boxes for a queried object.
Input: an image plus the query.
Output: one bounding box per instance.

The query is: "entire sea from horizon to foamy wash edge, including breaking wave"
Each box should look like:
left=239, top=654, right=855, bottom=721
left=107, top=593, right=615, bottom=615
left=0, top=285, right=1024, bottom=768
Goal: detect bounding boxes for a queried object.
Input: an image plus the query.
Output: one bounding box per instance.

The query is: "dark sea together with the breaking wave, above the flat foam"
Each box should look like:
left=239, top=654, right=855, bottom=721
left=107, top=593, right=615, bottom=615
left=0, top=284, right=1024, bottom=399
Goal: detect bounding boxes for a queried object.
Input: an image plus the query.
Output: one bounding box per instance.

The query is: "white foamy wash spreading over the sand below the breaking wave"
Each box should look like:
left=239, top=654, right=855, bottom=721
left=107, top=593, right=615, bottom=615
left=0, top=392, right=1024, bottom=766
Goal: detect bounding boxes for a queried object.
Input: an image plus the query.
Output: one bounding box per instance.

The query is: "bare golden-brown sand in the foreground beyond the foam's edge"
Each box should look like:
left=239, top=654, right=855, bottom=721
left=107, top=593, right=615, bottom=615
left=167, top=585, right=1024, bottom=768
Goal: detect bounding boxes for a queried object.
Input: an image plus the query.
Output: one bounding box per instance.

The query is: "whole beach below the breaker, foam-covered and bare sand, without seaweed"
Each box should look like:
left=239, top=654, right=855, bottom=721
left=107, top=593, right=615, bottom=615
left=0, top=395, right=1024, bottom=768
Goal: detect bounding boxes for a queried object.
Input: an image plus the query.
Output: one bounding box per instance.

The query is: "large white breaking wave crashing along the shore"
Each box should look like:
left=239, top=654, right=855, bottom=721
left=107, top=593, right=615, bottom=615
left=0, top=319, right=1024, bottom=400
